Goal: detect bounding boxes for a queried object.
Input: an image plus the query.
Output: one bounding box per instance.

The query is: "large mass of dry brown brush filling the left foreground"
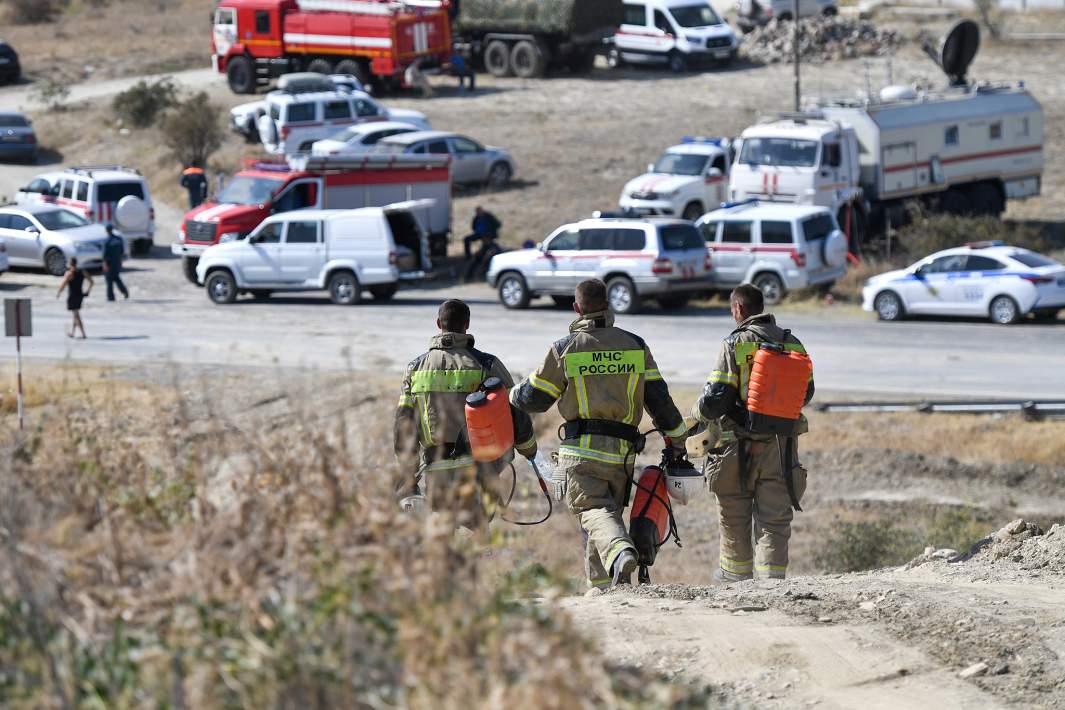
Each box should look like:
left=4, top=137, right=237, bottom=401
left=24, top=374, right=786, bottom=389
left=0, top=374, right=710, bottom=708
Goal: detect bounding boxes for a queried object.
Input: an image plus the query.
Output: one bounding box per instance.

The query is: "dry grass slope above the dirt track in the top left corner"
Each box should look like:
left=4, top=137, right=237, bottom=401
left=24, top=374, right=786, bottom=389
left=3, top=0, right=215, bottom=82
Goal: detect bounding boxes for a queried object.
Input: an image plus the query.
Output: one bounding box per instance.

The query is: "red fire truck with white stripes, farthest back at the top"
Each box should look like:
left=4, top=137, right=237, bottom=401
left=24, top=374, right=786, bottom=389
left=211, top=0, right=452, bottom=94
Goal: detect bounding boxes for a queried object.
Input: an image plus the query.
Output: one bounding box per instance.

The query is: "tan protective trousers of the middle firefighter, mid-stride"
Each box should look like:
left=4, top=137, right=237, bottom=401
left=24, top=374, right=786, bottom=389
left=558, top=457, right=636, bottom=589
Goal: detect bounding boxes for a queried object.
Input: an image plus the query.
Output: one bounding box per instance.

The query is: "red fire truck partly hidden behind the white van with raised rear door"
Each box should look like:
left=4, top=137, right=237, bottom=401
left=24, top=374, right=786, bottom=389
left=170, top=154, right=452, bottom=282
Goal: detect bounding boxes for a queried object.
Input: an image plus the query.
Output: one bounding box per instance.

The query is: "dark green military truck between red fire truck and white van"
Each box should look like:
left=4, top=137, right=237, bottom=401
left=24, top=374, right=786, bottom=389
left=450, top=0, right=624, bottom=79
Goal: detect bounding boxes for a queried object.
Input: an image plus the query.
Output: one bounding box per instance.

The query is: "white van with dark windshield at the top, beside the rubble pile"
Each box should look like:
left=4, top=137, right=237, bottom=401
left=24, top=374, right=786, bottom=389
left=608, top=0, right=739, bottom=71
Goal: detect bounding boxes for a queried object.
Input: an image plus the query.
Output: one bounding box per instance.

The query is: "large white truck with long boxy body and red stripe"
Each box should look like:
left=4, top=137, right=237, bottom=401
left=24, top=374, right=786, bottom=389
left=728, top=84, right=1044, bottom=244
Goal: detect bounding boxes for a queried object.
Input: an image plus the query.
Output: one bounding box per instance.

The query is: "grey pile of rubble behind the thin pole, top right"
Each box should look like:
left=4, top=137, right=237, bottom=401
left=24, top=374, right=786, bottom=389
left=740, top=16, right=903, bottom=64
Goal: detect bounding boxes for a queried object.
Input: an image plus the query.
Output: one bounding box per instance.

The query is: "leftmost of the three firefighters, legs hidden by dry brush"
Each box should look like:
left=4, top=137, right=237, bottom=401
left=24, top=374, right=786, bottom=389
left=394, top=300, right=537, bottom=530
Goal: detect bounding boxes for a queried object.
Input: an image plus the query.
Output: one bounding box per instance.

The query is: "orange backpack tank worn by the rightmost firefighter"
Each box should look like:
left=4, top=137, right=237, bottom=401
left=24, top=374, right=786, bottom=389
left=747, top=343, right=814, bottom=435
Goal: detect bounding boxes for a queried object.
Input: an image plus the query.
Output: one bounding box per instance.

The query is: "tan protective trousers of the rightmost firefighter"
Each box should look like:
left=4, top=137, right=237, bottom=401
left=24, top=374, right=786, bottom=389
left=706, top=439, right=806, bottom=581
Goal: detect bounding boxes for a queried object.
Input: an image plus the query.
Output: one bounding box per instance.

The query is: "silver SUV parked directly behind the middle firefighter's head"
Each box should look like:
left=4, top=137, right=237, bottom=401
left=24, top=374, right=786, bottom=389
left=488, top=217, right=712, bottom=313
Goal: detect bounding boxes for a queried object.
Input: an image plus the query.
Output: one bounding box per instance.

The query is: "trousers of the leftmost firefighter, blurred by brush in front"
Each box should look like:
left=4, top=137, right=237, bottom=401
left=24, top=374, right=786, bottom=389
left=421, top=457, right=502, bottom=532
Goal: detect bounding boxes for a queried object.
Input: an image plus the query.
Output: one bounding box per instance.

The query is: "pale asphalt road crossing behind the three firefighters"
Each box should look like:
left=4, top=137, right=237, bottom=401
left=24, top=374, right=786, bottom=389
left=0, top=254, right=1065, bottom=399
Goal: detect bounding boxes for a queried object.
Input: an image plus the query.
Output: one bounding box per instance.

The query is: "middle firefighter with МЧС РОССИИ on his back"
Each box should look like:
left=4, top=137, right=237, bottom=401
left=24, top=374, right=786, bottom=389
left=510, top=280, right=686, bottom=589
